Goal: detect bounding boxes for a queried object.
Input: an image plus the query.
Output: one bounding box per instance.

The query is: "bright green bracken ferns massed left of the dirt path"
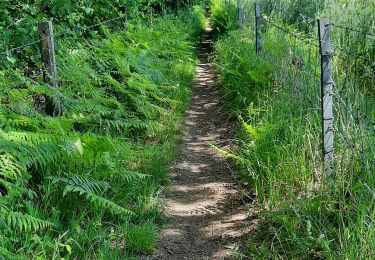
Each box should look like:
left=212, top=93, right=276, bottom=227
left=0, top=5, right=203, bottom=259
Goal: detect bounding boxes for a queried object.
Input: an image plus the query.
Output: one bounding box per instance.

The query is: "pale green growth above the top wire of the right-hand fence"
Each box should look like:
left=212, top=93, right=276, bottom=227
left=258, top=0, right=375, bottom=70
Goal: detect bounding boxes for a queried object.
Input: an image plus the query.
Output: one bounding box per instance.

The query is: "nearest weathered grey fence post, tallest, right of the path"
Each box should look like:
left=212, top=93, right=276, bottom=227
left=318, top=19, right=334, bottom=175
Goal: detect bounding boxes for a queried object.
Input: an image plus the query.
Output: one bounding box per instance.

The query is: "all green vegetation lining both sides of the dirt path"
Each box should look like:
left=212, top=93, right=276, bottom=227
left=0, top=0, right=375, bottom=259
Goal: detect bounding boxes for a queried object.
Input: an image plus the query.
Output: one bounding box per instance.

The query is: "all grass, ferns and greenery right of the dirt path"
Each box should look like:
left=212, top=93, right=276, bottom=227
left=211, top=0, right=375, bottom=259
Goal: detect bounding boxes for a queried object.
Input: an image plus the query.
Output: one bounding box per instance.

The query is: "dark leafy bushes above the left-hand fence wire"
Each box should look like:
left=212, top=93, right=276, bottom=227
left=0, top=0, right=202, bottom=55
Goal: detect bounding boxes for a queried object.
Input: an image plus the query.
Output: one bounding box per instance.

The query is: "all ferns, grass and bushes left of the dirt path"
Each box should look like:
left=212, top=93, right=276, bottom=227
left=0, top=1, right=204, bottom=259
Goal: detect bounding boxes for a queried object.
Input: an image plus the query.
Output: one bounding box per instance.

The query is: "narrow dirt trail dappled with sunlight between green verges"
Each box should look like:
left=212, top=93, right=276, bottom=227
left=153, top=10, right=249, bottom=260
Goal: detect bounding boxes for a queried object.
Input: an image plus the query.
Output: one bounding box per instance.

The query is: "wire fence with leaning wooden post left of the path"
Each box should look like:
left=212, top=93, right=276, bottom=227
left=0, top=10, right=140, bottom=120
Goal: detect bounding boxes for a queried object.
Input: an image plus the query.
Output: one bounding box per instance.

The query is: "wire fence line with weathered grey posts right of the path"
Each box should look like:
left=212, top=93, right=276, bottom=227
left=228, top=1, right=375, bottom=174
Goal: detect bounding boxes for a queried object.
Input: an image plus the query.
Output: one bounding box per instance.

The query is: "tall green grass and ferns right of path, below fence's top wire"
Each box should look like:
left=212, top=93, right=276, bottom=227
left=215, top=5, right=375, bottom=259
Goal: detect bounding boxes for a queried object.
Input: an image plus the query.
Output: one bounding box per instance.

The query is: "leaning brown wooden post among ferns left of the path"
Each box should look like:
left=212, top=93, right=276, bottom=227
left=38, top=21, right=62, bottom=116
